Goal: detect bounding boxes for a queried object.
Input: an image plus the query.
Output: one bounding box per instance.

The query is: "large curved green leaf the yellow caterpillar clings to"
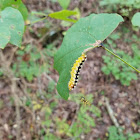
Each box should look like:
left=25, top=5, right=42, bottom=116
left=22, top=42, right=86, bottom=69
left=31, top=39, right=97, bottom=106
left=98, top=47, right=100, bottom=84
left=54, top=13, right=123, bottom=99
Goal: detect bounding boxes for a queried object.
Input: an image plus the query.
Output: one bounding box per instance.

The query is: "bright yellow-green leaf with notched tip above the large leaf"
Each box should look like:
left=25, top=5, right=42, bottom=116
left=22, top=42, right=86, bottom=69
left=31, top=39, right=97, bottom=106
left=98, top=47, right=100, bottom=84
left=48, top=10, right=77, bottom=23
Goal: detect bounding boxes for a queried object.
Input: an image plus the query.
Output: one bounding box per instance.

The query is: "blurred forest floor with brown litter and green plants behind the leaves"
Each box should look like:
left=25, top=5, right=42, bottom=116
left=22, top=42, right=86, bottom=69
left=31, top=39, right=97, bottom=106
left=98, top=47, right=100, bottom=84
left=0, top=0, right=140, bottom=140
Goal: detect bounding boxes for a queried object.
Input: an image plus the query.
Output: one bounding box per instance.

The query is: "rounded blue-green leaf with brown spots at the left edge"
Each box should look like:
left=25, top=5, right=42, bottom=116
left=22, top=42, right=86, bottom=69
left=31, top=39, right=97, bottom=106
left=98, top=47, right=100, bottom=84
left=0, top=7, right=24, bottom=48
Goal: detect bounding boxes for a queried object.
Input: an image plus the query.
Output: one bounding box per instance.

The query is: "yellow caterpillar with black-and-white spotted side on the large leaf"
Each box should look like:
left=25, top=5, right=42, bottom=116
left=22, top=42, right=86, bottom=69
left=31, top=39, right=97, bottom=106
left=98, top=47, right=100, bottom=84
left=68, top=53, right=87, bottom=91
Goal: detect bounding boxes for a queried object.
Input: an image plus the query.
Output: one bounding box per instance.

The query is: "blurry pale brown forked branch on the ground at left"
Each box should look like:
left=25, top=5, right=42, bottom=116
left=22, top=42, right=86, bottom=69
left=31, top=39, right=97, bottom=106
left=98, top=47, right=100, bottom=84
left=0, top=50, right=53, bottom=140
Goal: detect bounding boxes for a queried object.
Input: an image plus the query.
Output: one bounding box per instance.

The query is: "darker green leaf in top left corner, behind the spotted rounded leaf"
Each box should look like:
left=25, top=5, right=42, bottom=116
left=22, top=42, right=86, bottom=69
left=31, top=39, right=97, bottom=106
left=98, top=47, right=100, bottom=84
left=0, top=0, right=28, bottom=20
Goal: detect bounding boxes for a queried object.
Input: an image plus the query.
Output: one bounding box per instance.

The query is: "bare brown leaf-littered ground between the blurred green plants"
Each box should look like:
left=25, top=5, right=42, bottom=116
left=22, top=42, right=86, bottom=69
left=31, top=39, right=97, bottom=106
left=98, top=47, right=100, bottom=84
left=0, top=0, right=140, bottom=140
